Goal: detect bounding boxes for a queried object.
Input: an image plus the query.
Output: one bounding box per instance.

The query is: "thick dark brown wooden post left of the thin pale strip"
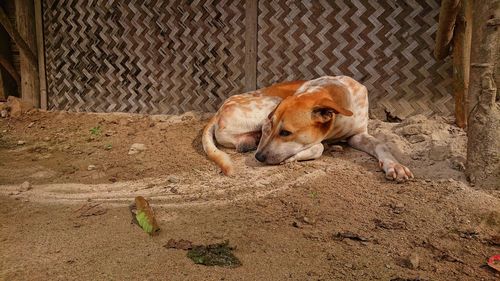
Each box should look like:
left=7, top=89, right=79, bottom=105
left=16, top=0, right=40, bottom=107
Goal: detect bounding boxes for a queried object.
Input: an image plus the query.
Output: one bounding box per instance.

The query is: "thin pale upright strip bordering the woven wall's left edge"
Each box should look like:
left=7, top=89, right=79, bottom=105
left=35, top=0, right=48, bottom=110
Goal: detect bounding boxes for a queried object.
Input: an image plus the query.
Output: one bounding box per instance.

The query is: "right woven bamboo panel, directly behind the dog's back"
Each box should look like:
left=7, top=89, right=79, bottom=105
left=257, top=0, right=454, bottom=117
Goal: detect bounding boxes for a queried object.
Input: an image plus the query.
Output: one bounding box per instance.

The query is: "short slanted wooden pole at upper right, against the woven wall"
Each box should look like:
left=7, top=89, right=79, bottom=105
left=434, top=0, right=460, bottom=59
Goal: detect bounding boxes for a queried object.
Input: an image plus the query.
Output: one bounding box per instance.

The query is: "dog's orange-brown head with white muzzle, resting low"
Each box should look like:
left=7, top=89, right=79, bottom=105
left=255, top=88, right=352, bottom=164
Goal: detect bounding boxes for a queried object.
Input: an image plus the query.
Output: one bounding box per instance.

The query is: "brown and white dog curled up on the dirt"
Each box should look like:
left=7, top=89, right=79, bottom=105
left=203, top=76, right=413, bottom=181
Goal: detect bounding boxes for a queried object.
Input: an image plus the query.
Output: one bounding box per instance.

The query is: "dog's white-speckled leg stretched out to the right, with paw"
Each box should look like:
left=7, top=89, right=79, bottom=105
left=348, top=132, right=413, bottom=182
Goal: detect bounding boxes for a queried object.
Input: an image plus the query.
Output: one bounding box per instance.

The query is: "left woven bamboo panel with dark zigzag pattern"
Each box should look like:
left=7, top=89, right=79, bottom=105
left=43, top=0, right=245, bottom=114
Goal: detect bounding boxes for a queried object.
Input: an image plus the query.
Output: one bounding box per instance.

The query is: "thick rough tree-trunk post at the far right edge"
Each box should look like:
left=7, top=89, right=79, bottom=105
left=466, top=0, right=500, bottom=190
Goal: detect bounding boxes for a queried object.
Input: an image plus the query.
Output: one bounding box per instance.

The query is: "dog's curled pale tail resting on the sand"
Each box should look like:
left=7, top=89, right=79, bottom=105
left=202, top=116, right=233, bottom=176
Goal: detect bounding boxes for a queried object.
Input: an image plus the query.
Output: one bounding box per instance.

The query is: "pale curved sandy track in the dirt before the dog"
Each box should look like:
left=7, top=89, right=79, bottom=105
left=0, top=159, right=328, bottom=207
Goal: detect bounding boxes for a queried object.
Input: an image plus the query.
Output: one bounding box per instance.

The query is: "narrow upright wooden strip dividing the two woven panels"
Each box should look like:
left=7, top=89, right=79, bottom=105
left=245, top=0, right=258, bottom=91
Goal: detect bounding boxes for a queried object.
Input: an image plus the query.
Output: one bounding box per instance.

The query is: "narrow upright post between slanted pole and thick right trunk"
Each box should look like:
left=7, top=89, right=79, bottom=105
left=452, top=0, right=473, bottom=128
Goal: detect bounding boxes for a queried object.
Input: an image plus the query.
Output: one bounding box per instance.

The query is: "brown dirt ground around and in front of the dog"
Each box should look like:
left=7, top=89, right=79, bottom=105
left=0, top=111, right=500, bottom=280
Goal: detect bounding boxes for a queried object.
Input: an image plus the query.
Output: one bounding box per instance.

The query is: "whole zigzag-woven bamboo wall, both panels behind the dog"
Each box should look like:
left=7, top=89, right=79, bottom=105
left=44, top=0, right=453, bottom=117
